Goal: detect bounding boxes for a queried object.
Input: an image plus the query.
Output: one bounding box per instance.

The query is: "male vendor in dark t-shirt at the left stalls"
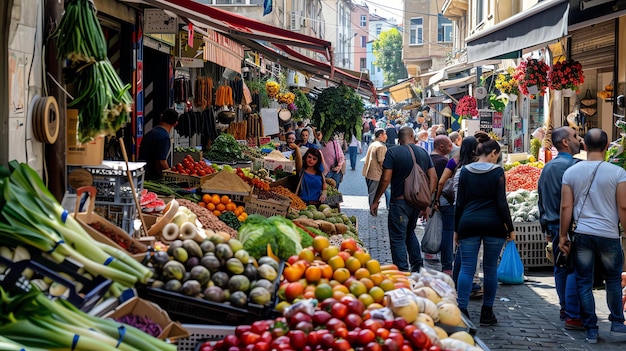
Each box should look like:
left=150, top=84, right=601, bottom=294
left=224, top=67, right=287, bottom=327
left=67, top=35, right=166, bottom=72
left=139, top=109, right=178, bottom=180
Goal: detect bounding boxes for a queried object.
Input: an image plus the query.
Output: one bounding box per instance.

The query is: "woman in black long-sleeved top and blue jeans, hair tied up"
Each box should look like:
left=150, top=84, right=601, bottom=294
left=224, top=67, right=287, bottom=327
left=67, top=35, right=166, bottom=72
left=454, top=133, right=515, bottom=325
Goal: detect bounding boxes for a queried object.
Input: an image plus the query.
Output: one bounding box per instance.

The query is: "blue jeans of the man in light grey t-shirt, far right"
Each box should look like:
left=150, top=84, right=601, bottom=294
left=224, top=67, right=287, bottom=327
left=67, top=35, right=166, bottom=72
left=573, top=233, right=624, bottom=329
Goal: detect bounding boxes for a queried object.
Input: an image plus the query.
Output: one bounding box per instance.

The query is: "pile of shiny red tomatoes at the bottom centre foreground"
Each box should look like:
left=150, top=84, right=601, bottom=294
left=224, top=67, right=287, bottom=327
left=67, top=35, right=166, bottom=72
left=200, top=296, right=440, bottom=351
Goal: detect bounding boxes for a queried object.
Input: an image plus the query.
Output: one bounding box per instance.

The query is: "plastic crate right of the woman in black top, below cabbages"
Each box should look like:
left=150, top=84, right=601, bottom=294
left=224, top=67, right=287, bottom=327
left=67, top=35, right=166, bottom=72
left=513, top=222, right=553, bottom=268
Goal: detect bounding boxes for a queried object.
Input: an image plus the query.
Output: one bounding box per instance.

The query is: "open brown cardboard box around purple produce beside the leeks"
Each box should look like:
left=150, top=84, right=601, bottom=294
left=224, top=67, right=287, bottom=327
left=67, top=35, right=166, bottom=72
left=103, top=297, right=189, bottom=340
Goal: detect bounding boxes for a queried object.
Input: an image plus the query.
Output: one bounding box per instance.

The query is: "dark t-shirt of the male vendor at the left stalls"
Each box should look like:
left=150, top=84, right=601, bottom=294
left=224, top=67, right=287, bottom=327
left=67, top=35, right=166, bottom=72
left=138, top=126, right=170, bottom=179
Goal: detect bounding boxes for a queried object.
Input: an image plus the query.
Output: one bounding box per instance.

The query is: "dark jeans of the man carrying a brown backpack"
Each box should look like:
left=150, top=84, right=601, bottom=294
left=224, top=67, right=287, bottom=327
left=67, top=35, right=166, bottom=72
left=387, top=199, right=424, bottom=272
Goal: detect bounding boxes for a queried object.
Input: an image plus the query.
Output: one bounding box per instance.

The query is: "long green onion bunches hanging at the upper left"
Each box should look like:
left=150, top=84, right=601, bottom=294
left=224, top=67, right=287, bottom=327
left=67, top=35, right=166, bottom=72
left=52, top=0, right=133, bottom=143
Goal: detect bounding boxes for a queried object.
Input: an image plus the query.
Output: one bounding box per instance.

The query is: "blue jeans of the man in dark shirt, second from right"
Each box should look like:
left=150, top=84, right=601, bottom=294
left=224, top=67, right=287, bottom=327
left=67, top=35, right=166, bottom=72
left=548, top=225, right=580, bottom=318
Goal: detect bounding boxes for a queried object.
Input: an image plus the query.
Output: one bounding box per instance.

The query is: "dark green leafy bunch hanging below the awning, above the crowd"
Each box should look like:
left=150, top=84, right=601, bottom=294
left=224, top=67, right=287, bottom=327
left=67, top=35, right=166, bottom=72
left=311, top=84, right=365, bottom=142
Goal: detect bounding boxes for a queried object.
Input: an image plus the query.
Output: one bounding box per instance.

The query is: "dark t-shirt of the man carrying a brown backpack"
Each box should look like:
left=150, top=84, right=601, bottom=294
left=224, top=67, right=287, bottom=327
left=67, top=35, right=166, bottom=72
left=383, top=144, right=434, bottom=199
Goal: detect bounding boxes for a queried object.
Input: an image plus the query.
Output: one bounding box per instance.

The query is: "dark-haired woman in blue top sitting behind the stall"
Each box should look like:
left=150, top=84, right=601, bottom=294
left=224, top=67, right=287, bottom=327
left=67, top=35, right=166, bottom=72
left=296, top=148, right=326, bottom=205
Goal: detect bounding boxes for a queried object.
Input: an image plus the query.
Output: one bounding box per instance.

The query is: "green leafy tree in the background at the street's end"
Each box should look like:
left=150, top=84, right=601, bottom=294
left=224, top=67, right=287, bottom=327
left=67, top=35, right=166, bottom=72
left=372, top=28, right=408, bottom=85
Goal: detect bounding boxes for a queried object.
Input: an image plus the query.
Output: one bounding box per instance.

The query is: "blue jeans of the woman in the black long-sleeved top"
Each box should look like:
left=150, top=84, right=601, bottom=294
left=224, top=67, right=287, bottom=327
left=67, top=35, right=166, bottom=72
left=457, top=236, right=506, bottom=308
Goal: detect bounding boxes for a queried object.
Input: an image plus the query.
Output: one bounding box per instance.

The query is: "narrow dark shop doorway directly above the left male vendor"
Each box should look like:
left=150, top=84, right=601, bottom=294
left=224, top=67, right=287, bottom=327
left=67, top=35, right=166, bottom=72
left=143, top=46, right=170, bottom=135
